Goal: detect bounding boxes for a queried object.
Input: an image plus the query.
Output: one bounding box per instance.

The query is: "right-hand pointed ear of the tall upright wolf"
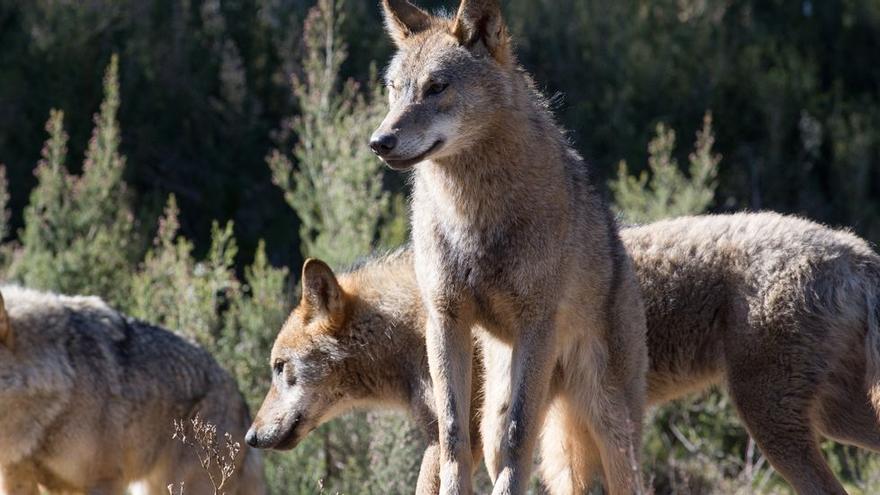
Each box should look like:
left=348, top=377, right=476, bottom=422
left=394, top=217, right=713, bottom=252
left=452, top=0, right=510, bottom=64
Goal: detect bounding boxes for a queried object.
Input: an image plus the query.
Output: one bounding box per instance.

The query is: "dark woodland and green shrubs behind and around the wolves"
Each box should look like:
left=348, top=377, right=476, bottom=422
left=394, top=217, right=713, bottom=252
left=0, top=0, right=880, bottom=494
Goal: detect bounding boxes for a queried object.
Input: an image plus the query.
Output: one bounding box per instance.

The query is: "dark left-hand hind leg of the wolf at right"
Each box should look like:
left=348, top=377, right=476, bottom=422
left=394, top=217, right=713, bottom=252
left=729, top=361, right=846, bottom=495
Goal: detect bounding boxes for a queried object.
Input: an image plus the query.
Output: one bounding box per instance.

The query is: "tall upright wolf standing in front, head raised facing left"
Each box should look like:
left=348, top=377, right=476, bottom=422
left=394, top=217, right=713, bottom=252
left=370, top=0, right=648, bottom=495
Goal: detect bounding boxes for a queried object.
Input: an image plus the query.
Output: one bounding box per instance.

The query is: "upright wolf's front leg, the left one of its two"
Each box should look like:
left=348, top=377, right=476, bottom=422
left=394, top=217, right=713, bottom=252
left=427, top=309, right=473, bottom=495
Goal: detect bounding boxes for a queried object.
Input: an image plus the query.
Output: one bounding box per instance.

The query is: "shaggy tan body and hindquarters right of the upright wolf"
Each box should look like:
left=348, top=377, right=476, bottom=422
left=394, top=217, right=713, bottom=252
left=622, top=213, right=880, bottom=494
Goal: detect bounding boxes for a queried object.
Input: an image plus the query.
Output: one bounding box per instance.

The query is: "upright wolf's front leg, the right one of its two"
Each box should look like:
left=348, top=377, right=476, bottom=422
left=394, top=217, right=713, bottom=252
left=486, top=315, right=556, bottom=495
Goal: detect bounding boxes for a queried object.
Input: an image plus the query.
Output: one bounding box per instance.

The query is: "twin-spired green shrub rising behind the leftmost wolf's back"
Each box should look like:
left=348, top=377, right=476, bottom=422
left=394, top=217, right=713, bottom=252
left=11, top=56, right=141, bottom=306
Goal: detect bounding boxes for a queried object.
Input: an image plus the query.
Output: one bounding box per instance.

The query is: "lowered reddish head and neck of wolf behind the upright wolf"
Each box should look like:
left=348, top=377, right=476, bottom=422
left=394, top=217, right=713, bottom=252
left=246, top=258, right=482, bottom=495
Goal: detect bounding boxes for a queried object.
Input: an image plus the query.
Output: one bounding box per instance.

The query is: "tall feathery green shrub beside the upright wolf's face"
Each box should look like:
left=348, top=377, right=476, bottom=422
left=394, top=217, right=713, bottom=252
left=268, top=0, right=395, bottom=266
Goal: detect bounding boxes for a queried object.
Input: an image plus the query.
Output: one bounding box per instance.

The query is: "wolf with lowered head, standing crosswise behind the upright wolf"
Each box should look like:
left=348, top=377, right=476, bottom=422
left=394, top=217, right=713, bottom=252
left=248, top=213, right=880, bottom=495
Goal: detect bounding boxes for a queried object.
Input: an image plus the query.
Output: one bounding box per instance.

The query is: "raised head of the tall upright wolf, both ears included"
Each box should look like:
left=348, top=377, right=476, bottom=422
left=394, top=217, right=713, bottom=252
left=370, top=0, right=516, bottom=170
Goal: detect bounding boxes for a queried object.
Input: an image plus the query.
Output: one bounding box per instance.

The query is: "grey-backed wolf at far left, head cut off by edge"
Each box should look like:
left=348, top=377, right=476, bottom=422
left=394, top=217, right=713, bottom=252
left=0, top=286, right=264, bottom=495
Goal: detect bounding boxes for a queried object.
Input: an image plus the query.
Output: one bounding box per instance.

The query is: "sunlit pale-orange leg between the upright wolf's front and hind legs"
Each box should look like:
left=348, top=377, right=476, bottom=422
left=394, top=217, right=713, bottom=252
left=539, top=399, right=602, bottom=495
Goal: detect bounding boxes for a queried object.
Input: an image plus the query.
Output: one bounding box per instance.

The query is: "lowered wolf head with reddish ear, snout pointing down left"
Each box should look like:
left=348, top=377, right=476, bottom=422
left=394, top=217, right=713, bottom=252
left=246, top=260, right=360, bottom=450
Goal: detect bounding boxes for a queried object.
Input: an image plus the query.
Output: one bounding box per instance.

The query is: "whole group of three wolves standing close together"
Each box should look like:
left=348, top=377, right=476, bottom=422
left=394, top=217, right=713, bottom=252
left=0, top=0, right=880, bottom=495
